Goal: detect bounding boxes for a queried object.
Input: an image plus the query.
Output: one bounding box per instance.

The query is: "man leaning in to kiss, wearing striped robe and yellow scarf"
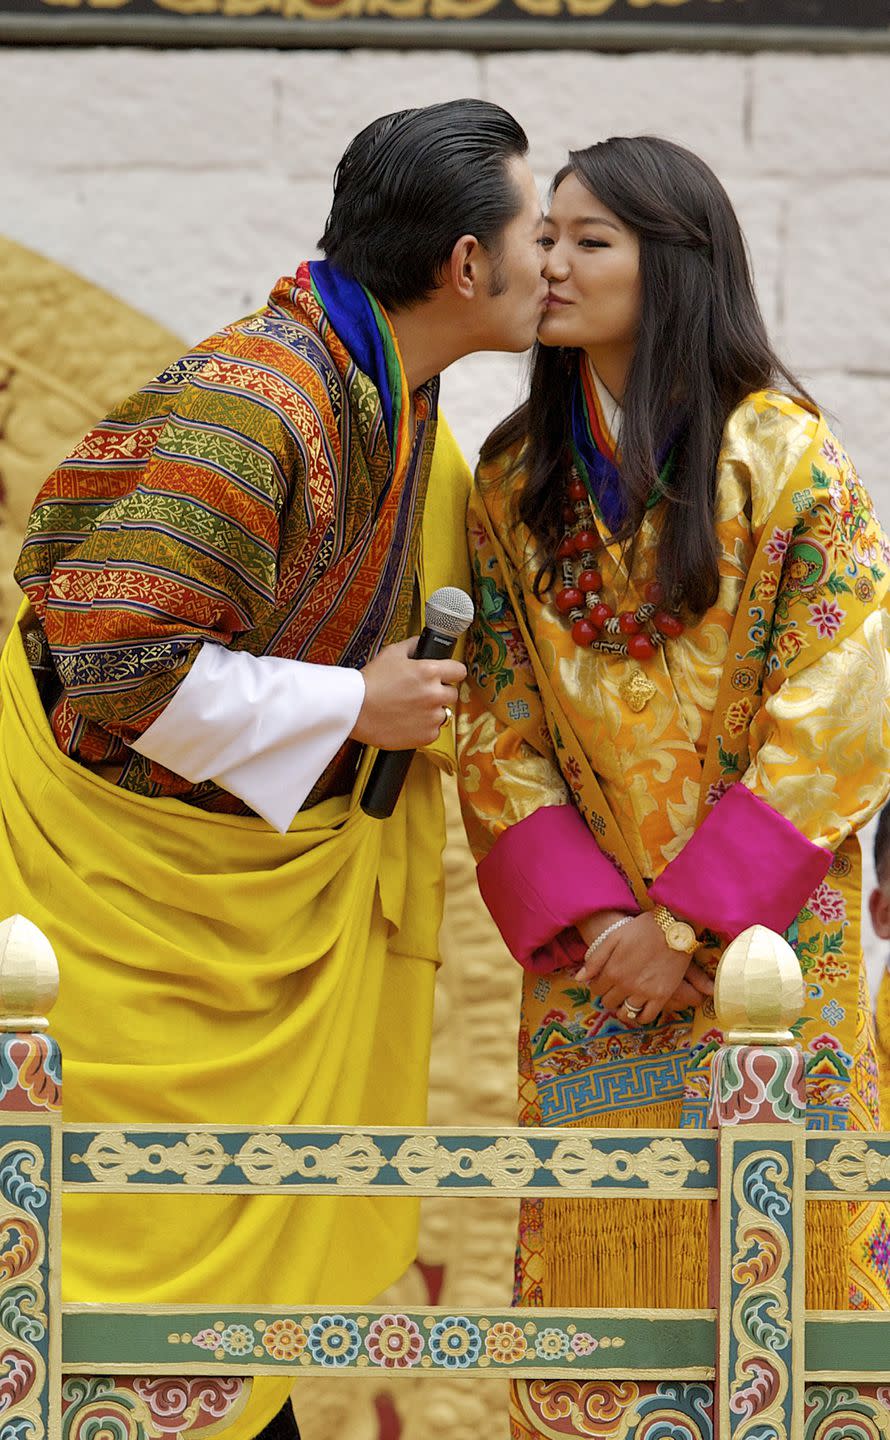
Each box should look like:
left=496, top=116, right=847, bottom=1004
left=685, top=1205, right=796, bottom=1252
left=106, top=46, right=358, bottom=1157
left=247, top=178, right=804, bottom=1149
left=0, top=99, right=546, bottom=1440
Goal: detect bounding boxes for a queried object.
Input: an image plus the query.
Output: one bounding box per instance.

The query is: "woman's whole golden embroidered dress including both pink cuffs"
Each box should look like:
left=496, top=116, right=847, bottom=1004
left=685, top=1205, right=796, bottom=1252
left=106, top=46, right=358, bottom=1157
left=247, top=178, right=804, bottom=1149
left=458, top=384, right=890, bottom=1436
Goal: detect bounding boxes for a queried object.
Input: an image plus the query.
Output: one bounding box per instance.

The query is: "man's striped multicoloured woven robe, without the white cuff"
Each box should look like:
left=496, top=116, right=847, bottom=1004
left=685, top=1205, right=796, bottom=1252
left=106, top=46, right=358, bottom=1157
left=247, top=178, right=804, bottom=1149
left=16, top=265, right=438, bottom=814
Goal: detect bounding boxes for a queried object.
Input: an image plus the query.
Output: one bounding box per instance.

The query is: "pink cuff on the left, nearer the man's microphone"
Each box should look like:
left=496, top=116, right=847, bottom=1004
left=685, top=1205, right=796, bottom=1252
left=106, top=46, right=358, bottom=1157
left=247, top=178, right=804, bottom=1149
left=477, top=805, right=639, bottom=969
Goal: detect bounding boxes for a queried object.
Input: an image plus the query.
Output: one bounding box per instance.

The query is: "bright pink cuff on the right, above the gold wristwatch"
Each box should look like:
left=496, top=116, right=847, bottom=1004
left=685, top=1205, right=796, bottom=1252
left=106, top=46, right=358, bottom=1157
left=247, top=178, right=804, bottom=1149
left=649, top=785, right=831, bottom=939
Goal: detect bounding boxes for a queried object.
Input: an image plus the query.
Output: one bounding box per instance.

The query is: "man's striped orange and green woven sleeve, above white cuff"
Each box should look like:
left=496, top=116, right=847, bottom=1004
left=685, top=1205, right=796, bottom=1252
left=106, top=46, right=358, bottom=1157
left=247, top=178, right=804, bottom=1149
left=20, top=341, right=311, bottom=742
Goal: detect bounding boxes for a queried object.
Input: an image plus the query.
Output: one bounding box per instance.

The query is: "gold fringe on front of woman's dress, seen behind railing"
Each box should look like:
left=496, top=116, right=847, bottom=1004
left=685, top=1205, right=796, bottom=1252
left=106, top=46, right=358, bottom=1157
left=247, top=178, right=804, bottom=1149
left=532, top=1100, right=709, bottom=1309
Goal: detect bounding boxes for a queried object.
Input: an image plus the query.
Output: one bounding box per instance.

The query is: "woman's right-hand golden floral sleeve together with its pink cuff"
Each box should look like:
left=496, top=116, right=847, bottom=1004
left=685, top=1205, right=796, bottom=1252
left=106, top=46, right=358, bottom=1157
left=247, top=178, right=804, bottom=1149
left=651, top=408, right=890, bottom=935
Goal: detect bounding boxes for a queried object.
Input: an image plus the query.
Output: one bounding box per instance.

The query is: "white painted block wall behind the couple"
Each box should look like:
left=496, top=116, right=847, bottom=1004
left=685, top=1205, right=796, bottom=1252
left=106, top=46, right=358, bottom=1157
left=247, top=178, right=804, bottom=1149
left=0, top=49, right=890, bottom=990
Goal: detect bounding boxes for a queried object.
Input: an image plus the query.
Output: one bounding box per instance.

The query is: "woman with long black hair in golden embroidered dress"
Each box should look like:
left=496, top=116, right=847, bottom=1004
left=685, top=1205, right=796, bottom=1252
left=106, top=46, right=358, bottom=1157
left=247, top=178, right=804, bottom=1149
left=459, top=138, right=890, bottom=1436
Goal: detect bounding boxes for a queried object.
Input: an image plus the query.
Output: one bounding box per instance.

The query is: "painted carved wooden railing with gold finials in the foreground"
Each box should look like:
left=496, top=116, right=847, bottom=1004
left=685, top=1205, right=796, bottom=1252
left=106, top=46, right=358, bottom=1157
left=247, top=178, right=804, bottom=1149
left=0, top=916, right=890, bottom=1440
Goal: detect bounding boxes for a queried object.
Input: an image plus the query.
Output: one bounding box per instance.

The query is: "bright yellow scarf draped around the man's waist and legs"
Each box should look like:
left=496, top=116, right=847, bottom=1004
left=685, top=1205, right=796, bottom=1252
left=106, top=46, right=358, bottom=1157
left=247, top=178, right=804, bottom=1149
left=0, top=420, right=469, bottom=1440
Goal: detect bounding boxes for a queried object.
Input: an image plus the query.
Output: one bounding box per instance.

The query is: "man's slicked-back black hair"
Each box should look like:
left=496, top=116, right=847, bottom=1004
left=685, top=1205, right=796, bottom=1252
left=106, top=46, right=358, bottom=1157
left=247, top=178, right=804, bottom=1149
left=318, top=99, right=529, bottom=310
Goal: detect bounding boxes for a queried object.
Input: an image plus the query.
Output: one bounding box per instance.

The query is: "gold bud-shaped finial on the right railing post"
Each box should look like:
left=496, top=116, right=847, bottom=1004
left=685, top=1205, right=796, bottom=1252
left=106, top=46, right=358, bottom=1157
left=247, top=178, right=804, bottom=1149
left=714, top=924, right=804, bottom=1045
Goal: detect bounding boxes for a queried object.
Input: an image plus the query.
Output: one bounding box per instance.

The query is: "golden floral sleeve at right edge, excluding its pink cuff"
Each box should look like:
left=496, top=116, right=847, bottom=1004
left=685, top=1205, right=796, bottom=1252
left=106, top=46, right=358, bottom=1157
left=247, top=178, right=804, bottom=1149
left=742, top=411, right=890, bottom=851
